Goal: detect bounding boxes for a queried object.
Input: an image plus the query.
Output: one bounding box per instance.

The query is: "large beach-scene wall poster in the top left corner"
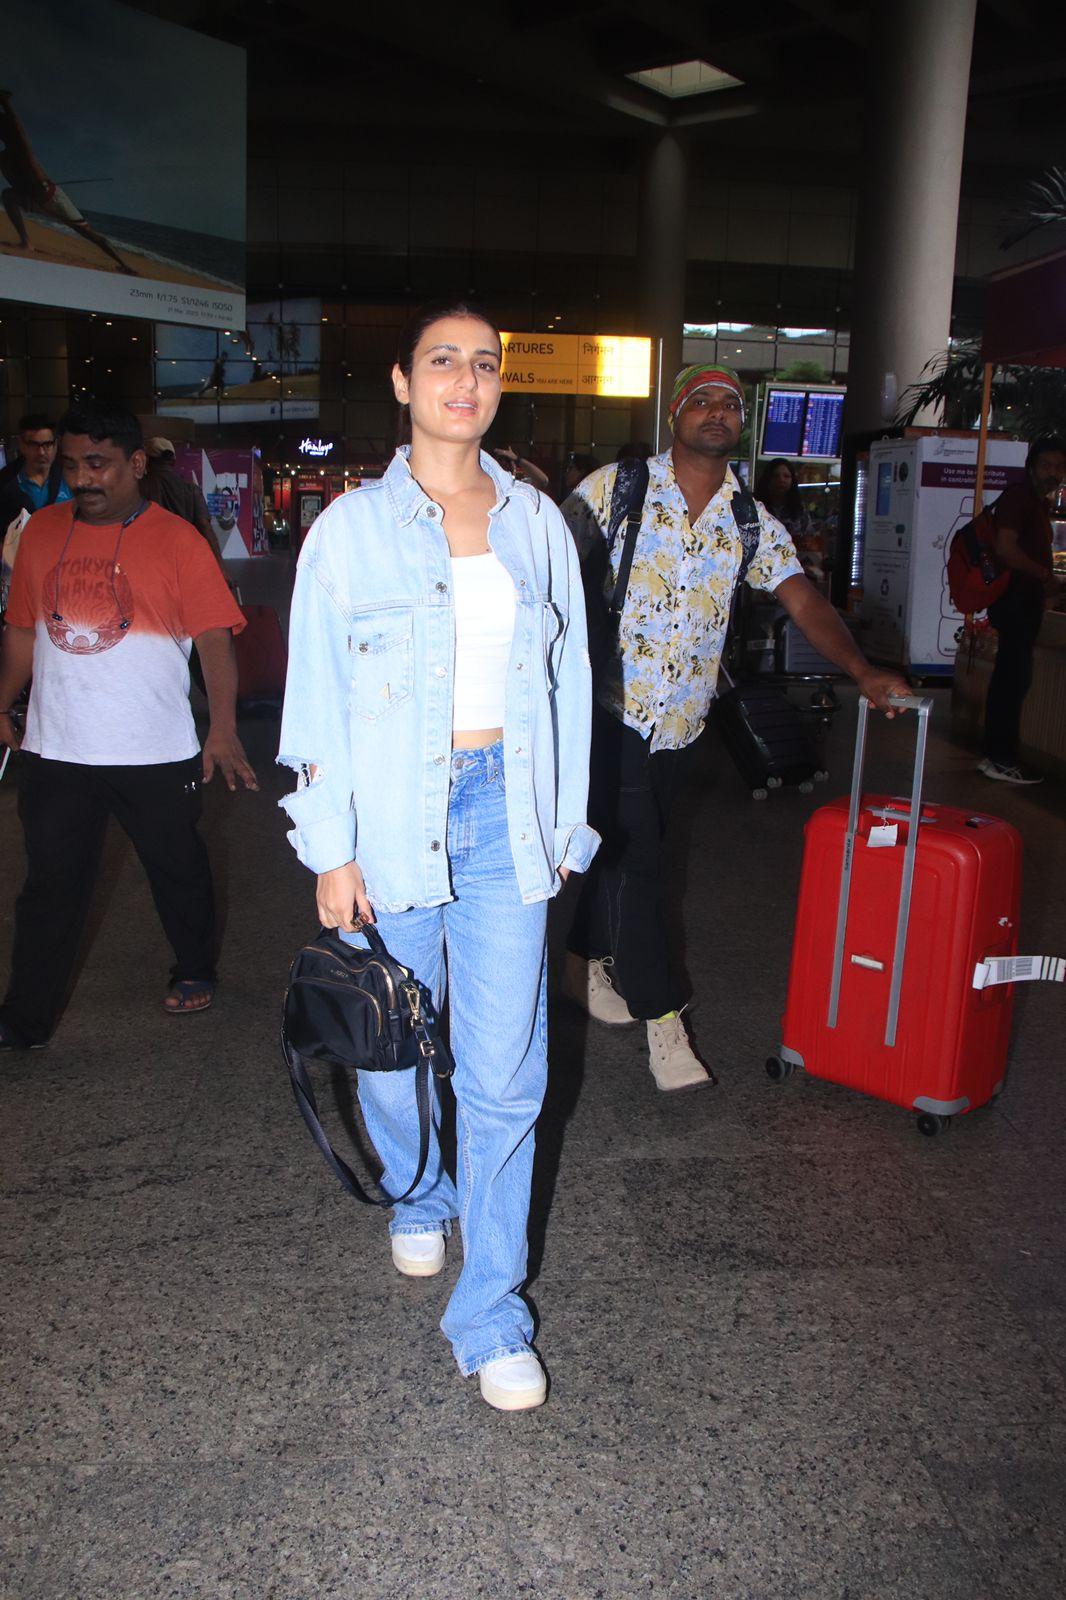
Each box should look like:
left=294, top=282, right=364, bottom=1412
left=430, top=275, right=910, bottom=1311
left=0, top=0, right=246, bottom=328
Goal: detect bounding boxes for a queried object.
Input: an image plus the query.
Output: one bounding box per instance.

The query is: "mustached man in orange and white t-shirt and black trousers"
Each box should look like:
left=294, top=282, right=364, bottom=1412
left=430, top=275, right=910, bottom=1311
left=0, top=402, right=256, bottom=1050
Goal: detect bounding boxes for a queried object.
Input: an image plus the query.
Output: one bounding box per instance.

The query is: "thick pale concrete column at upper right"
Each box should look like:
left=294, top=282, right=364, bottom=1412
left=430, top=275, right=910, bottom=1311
left=845, top=0, right=976, bottom=432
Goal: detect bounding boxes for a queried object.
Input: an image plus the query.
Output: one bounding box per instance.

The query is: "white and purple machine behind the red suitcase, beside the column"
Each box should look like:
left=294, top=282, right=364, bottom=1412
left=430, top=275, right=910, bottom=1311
left=863, top=432, right=1028, bottom=677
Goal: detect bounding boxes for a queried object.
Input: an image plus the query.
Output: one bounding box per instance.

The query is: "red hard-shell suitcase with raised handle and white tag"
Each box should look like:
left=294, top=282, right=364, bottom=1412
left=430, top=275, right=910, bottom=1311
left=767, top=699, right=1021, bottom=1134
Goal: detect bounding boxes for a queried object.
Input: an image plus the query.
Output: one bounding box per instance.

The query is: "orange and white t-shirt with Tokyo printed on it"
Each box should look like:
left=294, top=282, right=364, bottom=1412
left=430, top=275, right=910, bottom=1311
left=6, top=502, right=245, bottom=766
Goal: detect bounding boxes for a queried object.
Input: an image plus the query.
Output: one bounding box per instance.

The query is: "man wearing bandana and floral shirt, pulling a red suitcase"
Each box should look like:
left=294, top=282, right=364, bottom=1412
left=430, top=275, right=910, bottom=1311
left=562, top=365, right=909, bottom=1091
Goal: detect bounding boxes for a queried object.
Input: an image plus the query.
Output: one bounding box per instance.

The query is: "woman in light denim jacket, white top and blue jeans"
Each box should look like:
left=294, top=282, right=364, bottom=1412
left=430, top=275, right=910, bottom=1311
left=280, top=304, right=599, bottom=1410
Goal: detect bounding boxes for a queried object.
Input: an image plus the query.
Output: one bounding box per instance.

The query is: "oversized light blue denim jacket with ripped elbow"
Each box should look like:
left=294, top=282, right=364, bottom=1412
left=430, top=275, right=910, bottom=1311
left=279, top=450, right=599, bottom=910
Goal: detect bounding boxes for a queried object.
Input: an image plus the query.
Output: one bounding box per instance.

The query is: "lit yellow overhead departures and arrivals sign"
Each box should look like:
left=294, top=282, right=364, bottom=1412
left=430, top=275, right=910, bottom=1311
left=501, top=333, right=651, bottom=400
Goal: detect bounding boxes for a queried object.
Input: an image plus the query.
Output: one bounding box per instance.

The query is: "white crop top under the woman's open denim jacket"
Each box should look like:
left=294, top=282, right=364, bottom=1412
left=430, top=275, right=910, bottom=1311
left=451, top=550, right=515, bottom=731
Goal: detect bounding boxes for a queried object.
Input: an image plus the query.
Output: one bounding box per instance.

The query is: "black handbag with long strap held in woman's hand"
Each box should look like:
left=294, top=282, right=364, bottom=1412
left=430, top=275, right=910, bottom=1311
left=282, top=925, right=455, bottom=1206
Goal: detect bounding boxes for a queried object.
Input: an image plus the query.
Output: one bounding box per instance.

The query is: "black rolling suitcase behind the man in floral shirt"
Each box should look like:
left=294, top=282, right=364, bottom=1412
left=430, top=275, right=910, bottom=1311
left=712, top=669, right=829, bottom=800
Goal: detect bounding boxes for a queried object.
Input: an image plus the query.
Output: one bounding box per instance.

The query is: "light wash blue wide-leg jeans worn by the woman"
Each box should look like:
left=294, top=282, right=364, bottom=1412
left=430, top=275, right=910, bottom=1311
left=346, top=744, right=547, bottom=1376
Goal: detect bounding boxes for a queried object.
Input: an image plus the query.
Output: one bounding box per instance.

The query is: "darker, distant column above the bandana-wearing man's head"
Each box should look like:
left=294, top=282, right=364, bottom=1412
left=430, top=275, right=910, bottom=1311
left=634, top=133, right=688, bottom=450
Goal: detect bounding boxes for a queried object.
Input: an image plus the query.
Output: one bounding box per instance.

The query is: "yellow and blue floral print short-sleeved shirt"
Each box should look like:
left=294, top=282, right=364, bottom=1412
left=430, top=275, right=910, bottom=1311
left=562, top=450, right=804, bottom=752
